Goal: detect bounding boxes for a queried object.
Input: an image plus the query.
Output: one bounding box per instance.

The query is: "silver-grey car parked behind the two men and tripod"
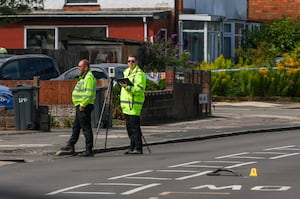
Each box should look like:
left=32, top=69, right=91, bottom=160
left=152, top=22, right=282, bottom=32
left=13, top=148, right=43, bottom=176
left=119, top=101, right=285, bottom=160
left=53, top=63, right=158, bottom=83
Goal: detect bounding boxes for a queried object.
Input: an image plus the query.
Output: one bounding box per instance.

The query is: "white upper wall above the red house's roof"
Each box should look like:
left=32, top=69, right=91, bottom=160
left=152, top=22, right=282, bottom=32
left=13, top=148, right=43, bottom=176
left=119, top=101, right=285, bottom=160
left=44, top=0, right=175, bottom=9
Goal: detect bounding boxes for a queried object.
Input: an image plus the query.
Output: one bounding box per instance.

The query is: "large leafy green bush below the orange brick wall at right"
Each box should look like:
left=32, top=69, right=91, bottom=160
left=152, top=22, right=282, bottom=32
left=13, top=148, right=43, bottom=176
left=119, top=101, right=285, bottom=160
left=240, top=17, right=300, bottom=66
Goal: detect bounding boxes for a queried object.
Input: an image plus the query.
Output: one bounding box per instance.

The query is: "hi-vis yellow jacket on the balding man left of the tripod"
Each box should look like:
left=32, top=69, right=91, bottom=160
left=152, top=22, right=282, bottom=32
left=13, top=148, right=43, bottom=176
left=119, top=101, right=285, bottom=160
left=72, top=70, right=96, bottom=107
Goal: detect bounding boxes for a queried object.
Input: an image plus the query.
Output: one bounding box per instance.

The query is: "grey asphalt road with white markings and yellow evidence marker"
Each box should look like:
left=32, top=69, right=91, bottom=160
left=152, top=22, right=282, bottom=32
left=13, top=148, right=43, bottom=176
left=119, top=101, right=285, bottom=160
left=0, top=130, right=300, bottom=199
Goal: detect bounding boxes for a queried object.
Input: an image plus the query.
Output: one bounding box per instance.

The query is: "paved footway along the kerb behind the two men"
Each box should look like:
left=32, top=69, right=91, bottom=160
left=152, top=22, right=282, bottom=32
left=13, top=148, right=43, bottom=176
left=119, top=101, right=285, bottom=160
left=0, top=101, right=300, bottom=166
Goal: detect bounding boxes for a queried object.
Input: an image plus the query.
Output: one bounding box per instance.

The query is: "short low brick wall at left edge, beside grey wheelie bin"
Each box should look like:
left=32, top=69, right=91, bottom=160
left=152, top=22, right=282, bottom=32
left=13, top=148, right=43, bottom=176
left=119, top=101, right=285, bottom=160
left=0, top=106, right=15, bottom=130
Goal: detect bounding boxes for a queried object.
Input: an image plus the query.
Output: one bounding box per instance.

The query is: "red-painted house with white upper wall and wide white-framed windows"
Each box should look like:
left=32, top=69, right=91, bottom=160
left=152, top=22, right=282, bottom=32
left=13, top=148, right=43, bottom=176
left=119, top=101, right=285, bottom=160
left=0, top=0, right=176, bottom=62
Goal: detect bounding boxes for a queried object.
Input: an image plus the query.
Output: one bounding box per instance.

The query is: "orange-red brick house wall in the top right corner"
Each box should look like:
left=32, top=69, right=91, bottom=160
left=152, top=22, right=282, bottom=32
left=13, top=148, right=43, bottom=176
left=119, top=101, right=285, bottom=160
left=248, top=0, right=300, bottom=22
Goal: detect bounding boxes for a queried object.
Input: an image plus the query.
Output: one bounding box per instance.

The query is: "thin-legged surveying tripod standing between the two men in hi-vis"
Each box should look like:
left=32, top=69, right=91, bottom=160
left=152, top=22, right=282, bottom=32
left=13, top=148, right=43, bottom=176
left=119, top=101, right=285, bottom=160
left=94, top=77, right=151, bottom=153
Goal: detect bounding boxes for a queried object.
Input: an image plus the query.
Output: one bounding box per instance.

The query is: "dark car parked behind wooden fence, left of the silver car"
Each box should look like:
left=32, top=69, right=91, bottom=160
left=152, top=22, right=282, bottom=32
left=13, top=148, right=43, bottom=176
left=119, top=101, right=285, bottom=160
left=0, top=54, right=60, bottom=80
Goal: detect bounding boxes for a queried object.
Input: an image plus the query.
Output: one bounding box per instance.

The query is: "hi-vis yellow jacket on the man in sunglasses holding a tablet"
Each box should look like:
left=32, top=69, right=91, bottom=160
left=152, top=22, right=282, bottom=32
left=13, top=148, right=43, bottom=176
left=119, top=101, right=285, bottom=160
left=120, top=66, right=146, bottom=116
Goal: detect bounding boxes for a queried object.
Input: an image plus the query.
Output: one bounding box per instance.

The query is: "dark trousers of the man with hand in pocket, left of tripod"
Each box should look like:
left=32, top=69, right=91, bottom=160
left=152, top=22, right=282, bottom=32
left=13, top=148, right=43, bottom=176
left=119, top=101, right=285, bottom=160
left=68, top=104, right=94, bottom=151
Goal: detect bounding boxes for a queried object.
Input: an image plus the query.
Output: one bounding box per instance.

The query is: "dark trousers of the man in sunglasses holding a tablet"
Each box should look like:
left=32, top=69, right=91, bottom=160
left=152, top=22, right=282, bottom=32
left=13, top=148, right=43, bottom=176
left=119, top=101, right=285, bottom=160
left=124, top=114, right=143, bottom=151
